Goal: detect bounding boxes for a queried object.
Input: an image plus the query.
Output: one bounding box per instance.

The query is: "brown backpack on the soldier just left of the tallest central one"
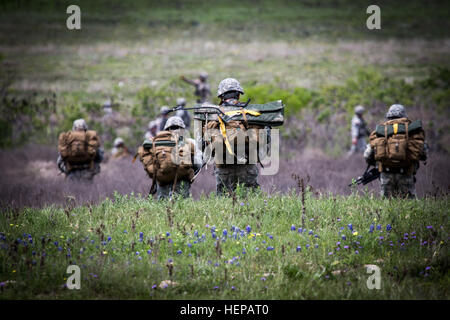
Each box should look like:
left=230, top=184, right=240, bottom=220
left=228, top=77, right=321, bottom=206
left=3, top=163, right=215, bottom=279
left=138, top=131, right=195, bottom=185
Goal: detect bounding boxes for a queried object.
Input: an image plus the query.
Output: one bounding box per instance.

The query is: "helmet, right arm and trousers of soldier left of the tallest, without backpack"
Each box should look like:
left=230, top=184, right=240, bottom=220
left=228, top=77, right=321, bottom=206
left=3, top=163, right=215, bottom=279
left=156, top=116, right=202, bottom=200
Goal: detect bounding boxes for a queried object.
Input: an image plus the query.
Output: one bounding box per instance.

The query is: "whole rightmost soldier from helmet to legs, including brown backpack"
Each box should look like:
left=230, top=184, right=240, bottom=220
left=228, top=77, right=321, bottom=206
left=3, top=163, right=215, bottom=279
left=364, top=104, right=428, bottom=199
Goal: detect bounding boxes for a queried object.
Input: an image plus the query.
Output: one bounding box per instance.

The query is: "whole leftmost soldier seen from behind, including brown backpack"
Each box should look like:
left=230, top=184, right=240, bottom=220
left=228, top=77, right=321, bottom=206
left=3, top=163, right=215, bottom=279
left=57, top=119, right=103, bottom=182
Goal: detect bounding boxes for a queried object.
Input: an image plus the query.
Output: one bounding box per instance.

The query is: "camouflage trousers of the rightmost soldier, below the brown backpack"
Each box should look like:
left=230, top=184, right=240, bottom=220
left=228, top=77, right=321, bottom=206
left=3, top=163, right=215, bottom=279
left=380, top=172, right=416, bottom=199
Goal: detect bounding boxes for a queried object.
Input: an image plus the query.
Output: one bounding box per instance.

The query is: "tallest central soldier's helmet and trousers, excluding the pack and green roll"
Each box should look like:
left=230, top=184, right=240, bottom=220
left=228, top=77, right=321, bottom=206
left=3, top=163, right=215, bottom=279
left=214, top=78, right=259, bottom=195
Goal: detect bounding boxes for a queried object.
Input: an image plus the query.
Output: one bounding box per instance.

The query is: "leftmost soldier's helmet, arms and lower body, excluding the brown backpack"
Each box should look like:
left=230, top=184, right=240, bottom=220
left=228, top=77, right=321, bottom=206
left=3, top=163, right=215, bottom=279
left=57, top=119, right=104, bottom=182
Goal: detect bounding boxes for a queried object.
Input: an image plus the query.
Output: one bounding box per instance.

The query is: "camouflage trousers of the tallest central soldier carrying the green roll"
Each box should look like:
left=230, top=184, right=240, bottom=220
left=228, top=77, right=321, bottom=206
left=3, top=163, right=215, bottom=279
left=214, top=164, right=259, bottom=195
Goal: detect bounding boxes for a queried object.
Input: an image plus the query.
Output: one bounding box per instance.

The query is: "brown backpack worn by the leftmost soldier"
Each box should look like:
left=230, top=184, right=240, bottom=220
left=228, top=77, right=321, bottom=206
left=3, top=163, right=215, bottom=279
left=58, top=130, right=100, bottom=171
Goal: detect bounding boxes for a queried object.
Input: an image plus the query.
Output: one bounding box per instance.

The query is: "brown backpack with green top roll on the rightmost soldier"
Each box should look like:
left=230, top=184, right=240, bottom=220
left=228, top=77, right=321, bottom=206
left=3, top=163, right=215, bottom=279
left=370, top=118, right=425, bottom=171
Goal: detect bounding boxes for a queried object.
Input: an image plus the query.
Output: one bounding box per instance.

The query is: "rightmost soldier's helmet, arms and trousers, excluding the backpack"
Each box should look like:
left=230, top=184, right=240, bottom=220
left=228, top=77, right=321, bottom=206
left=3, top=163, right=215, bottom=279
left=364, top=104, right=428, bottom=199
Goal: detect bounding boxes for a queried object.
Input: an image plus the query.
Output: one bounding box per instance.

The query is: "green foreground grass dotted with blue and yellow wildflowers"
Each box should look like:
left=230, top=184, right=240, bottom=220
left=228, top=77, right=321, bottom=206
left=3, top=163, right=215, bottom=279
left=0, top=192, right=450, bottom=299
